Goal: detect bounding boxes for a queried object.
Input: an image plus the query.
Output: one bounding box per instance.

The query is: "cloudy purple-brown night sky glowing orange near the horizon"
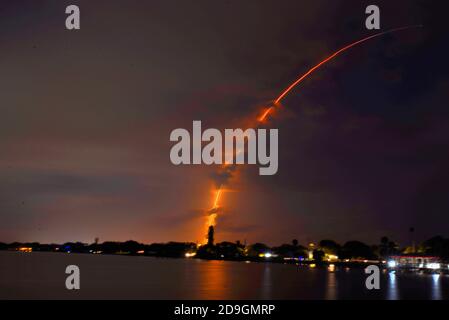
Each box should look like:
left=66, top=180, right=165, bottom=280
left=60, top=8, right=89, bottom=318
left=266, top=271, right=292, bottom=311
left=0, top=0, right=449, bottom=245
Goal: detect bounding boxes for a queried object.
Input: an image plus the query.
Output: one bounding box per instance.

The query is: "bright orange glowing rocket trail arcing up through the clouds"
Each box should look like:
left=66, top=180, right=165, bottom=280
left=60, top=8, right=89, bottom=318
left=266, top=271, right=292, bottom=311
left=203, top=25, right=422, bottom=240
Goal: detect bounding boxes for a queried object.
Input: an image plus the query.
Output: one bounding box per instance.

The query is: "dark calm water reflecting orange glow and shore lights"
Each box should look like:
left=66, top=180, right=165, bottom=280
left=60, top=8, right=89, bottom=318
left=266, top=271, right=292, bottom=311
left=0, top=251, right=449, bottom=299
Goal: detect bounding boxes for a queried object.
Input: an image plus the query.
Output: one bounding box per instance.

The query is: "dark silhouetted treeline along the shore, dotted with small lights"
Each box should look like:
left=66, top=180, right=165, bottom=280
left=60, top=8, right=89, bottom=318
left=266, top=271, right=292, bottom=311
left=0, top=236, right=449, bottom=262
